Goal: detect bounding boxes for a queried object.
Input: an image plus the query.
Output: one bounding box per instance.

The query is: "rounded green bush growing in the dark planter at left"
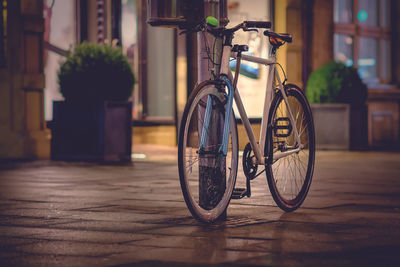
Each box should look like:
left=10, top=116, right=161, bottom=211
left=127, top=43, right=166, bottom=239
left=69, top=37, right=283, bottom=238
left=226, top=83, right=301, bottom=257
left=58, top=42, right=135, bottom=103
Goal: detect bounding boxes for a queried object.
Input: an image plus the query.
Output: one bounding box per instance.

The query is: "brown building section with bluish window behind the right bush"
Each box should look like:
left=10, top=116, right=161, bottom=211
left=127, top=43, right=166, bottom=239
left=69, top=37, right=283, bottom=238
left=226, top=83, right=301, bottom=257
left=282, top=0, right=400, bottom=149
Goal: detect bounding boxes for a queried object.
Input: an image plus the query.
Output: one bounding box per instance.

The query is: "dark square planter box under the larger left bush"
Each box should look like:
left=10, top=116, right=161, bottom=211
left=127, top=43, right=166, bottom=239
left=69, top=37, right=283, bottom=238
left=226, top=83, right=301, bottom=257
left=50, top=101, right=132, bottom=162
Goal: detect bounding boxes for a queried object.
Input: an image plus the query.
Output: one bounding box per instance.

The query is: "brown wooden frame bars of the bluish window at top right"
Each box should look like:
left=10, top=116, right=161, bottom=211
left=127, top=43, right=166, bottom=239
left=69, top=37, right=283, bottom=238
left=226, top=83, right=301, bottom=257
left=333, top=0, right=392, bottom=87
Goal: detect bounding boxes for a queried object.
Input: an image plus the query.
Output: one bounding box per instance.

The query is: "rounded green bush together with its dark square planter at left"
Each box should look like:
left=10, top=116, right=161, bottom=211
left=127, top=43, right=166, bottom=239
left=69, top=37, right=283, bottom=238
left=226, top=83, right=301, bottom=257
left=50, top=42, right=134, bottom=161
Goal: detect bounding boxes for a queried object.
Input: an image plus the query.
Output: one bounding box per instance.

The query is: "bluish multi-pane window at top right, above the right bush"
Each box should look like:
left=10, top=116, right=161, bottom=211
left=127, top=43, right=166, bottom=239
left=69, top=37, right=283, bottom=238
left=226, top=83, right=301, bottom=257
left=334, top=0, right=391, bottom=86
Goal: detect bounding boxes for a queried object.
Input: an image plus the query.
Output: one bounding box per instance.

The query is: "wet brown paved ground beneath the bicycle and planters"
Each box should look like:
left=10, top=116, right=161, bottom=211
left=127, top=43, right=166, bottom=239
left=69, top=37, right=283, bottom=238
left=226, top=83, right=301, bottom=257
left=0, top=146, right=400, bottom=266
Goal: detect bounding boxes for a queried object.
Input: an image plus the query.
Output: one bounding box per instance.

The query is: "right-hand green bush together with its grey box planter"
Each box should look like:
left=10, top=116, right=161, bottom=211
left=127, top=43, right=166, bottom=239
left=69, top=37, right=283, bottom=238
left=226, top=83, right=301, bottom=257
left=306, top=62, right=367, bottom=149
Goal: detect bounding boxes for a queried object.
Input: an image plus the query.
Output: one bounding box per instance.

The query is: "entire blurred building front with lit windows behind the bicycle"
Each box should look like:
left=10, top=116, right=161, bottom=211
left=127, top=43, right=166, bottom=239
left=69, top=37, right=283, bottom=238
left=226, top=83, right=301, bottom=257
left=0, top=0, right=400, bottom=158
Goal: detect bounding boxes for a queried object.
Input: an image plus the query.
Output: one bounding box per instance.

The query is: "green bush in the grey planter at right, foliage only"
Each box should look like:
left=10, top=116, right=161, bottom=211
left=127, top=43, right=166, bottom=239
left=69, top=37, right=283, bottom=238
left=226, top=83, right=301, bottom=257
left=306, top=62, right=367, bottom=105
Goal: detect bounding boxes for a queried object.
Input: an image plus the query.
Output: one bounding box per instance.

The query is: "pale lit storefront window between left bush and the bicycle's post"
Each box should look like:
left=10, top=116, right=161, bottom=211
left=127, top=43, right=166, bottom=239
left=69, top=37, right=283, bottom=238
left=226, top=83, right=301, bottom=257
left=120, top=0, right=175, bottom=123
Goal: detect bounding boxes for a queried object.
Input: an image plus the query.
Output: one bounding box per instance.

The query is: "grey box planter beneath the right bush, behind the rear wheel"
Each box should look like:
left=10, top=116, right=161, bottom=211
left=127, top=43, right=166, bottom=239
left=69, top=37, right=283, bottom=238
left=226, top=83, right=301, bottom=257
left=311, top=104, right=367, bottom=150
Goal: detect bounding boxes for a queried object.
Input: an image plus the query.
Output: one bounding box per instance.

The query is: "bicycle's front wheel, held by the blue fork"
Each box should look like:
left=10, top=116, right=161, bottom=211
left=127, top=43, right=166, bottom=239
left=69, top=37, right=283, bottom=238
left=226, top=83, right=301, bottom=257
left=178, top=81, right=238, bottom=222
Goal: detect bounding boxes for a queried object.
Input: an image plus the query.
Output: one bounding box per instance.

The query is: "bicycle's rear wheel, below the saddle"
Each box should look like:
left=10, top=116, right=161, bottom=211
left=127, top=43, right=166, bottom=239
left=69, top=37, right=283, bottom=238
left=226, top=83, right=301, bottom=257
left=265, top=85, right=315, bottom=211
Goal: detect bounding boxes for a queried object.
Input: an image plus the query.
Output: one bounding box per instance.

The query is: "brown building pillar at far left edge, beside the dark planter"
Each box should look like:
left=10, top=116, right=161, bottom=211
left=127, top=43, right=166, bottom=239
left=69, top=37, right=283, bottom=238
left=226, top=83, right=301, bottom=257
left=0, top=0, right=50, bottom=158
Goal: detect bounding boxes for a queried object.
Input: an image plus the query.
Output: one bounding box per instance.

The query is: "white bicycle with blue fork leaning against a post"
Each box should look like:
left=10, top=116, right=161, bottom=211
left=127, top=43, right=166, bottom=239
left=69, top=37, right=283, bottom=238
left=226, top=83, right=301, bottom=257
left=178, top=18, right=315, bottom=223
